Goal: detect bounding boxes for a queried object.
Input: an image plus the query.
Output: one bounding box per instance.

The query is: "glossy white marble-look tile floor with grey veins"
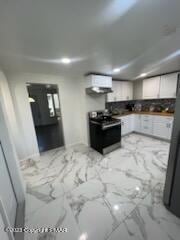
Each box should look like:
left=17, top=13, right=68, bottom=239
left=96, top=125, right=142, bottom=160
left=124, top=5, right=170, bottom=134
left=21, top=134, right=180, bottom=240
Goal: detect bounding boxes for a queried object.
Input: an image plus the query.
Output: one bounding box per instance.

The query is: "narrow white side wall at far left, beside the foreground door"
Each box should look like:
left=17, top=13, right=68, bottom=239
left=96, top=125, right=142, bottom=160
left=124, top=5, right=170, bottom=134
left=0, top=72, right=25, bottom=203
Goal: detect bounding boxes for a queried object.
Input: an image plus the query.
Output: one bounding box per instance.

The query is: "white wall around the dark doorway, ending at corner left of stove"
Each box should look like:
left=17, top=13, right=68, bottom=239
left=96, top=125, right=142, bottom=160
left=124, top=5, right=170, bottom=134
left=7, top=73, right=82, bottom=159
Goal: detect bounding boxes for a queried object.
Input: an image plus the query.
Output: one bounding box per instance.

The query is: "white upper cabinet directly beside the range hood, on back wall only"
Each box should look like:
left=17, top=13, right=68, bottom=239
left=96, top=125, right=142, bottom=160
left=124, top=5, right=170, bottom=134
left=107, top=81, right=133, bottom=102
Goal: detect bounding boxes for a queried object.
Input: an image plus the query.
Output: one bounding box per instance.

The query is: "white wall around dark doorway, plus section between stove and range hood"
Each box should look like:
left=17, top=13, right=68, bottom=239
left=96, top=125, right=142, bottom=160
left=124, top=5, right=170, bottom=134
left=4, top=73, right=105, bottom=160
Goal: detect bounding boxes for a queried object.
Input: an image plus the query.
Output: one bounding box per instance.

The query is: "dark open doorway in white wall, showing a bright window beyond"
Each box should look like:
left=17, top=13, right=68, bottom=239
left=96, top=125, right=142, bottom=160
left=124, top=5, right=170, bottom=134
left=27, top=84, right=64, bottom=152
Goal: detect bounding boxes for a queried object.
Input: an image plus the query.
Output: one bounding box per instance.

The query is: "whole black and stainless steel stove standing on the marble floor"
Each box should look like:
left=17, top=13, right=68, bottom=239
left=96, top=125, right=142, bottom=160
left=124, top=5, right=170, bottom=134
left=89, top=110, right=121, bottom=154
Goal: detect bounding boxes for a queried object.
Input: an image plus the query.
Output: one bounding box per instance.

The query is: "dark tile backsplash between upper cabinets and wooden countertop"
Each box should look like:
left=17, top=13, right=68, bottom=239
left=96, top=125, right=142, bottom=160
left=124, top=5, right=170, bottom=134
left=106, top=98, right=176, bottom=113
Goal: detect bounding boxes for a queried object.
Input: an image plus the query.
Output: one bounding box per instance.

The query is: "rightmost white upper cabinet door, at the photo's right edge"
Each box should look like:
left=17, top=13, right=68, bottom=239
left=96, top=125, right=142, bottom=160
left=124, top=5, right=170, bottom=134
left=160, top=73, right=178, bottom=98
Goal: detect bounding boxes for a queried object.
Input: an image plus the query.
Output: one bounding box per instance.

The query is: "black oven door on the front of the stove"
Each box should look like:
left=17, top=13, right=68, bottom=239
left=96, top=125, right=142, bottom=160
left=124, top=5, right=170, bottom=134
left=102, top=124, right=121, bottom=148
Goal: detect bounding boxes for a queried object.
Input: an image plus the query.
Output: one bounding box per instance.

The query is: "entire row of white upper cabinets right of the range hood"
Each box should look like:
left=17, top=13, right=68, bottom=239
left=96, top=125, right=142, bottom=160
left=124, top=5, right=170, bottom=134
left=107, top=73, right=178, bottom=102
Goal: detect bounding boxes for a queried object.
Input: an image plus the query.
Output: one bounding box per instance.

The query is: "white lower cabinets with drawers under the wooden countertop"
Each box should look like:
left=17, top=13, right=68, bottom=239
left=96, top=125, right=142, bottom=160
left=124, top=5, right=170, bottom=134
left=118, top=114, right=174, bottom=140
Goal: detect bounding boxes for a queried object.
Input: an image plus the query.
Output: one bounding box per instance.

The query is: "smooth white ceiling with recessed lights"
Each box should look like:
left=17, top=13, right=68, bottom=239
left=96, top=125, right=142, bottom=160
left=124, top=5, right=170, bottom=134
left=0, top=0, right=180, bottom=79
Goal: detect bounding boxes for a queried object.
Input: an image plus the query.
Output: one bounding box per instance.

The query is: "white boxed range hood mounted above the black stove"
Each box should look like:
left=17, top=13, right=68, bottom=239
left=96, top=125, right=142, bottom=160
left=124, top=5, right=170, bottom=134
left=86, top=74, right=112, bottom=94
